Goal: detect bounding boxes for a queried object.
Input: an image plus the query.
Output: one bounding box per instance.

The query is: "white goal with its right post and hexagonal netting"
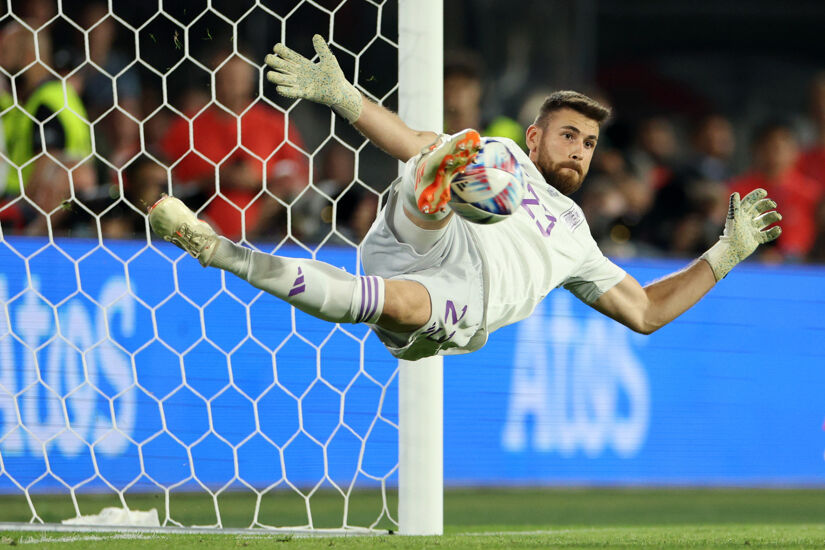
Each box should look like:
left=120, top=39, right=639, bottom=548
left=0, top=0, right=443, bottom=535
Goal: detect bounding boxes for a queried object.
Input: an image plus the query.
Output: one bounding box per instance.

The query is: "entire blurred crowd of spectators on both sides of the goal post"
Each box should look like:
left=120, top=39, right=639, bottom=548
left=0, top=0, right=825, bottom=262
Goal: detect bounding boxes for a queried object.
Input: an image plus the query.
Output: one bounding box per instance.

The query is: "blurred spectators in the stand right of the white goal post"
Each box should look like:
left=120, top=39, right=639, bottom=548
left=444, top=52, right=825, bottom=262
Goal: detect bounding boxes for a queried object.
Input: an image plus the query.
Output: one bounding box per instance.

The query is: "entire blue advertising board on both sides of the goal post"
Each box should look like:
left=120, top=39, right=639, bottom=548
left=0, top=238, right=825, bottom=492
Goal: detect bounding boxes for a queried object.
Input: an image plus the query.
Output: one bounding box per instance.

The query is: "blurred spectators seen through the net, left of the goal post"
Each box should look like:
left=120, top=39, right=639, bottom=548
left=0, top=0, right=379, bottom=243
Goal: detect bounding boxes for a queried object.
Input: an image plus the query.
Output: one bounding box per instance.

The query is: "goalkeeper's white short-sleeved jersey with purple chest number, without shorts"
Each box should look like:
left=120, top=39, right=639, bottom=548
left=466, top=138, right=625, bottom=332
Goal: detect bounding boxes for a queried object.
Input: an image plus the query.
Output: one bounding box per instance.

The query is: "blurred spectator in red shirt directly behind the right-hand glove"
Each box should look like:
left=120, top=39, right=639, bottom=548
left=730, top=122, right=822, bottom=260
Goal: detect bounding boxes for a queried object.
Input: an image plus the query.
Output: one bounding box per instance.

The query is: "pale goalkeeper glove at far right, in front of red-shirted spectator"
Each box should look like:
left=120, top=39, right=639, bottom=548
left=701, top=189, right=782, bottom=281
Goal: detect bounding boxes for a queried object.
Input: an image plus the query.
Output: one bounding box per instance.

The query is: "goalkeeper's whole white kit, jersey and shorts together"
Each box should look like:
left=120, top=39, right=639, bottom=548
left=361, top=138, right=625, bottom=361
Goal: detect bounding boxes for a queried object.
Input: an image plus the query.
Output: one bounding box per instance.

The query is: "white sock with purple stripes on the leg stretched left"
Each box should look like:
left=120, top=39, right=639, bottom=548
left=210, top=237, right=384, bottom=323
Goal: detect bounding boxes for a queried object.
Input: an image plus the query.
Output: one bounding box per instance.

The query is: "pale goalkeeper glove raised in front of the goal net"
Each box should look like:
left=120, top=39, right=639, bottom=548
left=266, top=34, right=362, bottom=122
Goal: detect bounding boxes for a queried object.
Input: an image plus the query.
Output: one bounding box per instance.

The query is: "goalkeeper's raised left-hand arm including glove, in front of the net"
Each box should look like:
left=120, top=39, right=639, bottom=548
left=266, top=34, right=437, bottom=161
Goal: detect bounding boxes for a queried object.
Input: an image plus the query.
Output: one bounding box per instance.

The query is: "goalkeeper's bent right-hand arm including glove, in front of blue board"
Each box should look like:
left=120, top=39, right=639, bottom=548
left=593, top=189, right=782, bottom=334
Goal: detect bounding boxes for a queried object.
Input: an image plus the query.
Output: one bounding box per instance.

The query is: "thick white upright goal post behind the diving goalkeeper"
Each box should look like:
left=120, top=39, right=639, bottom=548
left=398, top=0, right=444, bottom=535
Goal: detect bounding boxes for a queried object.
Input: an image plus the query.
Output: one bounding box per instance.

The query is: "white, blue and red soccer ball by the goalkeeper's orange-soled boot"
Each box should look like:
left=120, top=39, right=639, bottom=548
left=449, top=139, right=524, bottom=224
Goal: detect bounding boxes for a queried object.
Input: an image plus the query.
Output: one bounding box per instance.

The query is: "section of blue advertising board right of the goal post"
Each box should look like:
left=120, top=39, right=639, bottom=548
left=444, top=261, right=825, bottom=485
